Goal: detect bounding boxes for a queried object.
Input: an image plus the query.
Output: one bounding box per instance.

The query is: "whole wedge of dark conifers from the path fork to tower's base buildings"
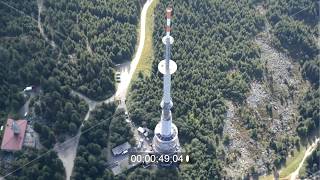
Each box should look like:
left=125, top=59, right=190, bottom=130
left=72, top=104, right=135, bottom=180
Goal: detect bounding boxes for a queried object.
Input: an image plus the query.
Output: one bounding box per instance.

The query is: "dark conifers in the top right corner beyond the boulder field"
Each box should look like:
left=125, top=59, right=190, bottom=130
left=267, top=0, right=320, bottom=86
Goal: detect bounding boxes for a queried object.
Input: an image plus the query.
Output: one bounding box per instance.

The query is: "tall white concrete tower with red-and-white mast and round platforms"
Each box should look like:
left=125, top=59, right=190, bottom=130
left=153, top=7, right=180, bottom=155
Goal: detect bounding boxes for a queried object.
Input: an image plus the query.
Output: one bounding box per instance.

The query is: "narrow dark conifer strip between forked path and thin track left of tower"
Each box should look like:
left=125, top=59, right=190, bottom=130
left=72, top=105, right=115, bottom=179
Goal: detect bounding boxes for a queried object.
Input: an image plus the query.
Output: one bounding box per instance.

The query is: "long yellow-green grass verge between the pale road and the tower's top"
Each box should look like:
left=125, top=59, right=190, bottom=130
left=133, top=0, right=159, bottom=81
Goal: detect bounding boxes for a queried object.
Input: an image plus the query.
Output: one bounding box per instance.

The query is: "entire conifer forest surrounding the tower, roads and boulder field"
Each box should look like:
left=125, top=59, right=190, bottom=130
left=0, top=0, right=320, bottom=180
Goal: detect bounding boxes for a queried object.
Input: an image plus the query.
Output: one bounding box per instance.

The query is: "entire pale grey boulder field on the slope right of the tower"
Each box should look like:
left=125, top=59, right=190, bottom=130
left=223, top=4, right=306, bottom=176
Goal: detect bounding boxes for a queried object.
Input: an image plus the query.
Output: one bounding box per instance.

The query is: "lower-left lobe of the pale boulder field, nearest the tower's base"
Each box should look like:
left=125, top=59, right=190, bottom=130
left=224, top=101, right=271, bottom=179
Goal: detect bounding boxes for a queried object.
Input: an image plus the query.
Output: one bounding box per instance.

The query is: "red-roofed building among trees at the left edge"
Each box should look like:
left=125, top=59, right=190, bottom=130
left=1, top=119, right=27, bottom=151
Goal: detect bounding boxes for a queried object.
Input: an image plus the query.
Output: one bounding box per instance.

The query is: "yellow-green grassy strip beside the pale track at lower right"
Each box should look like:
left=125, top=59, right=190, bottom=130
left=280, top=147, right=306, bottom=178
